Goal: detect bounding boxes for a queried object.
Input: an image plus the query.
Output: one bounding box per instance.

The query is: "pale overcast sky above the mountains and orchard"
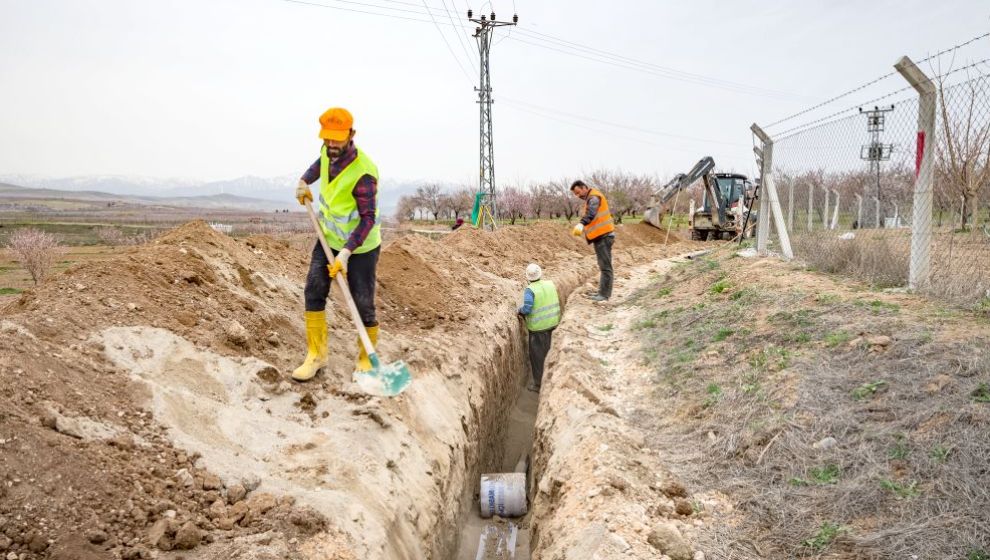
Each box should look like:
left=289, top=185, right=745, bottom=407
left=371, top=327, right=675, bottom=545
left=0, top=0, right=990, bottom=184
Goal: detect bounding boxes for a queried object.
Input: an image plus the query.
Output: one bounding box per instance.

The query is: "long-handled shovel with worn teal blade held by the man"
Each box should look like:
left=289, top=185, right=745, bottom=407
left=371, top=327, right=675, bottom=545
left=306, top=202, right=412, bottom=397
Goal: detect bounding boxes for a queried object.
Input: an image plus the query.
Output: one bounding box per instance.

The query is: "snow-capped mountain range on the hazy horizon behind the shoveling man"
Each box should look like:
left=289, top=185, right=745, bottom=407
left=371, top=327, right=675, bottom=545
left=0, top=174, right=434, bottom=216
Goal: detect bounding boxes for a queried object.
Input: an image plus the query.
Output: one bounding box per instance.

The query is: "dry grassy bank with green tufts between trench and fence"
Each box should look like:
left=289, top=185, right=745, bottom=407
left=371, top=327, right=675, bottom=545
left=637, top=259, right=990, bottom=559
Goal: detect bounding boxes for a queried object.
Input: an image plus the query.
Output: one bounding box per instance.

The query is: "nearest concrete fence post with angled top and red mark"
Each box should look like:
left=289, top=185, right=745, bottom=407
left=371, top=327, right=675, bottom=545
left=894, top=56, right=937, bottom=290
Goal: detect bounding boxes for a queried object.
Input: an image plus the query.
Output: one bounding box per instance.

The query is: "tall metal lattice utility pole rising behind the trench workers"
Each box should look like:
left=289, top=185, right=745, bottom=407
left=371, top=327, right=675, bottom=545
left=468, top=10, right=519, bottom=229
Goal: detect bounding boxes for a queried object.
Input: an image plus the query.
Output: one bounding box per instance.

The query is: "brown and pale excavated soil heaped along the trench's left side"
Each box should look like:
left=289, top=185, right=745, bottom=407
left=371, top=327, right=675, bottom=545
left=0, top=222, right=690, bottom=560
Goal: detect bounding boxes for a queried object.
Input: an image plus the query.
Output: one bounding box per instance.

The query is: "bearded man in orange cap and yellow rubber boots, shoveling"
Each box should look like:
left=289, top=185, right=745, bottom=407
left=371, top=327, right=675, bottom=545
left=292, top=107, right=382, bottom=381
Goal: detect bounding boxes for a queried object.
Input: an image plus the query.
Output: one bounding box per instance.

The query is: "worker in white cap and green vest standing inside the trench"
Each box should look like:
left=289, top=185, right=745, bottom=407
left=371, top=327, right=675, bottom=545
left=518, top=263, right=560, bottom=393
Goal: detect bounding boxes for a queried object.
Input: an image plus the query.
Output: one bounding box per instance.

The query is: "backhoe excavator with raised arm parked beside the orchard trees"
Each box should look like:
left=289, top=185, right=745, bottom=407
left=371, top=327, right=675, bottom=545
left=643, top=156, right=756, bottom=241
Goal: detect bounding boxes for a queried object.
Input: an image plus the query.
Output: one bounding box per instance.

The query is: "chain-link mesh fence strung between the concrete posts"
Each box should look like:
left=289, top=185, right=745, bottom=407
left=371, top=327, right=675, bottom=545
left=772, top=63, right=990, bottom=308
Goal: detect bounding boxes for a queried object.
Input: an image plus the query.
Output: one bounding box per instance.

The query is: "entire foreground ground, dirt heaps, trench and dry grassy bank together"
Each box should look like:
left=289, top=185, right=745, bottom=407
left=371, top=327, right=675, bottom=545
left=0, top=214, right=990, bottom=560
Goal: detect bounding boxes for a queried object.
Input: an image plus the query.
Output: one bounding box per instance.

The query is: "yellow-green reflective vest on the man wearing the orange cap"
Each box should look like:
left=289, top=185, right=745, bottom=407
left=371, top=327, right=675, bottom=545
left=320, top=146, right=382, bottom=256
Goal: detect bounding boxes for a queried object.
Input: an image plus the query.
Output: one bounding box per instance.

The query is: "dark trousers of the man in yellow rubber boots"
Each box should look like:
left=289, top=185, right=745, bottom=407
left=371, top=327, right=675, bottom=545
left=305, top=240, right=381, bottom=327
